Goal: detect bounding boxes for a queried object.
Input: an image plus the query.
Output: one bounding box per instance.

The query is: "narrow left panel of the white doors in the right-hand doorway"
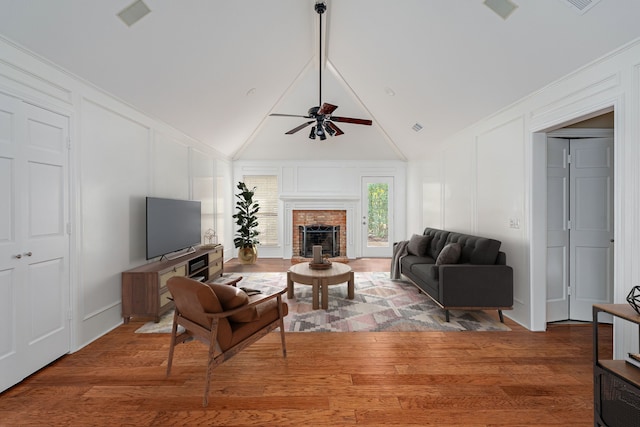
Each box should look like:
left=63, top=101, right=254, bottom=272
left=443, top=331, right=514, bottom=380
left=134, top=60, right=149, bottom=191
left=547, top=138, right=569, bottom=322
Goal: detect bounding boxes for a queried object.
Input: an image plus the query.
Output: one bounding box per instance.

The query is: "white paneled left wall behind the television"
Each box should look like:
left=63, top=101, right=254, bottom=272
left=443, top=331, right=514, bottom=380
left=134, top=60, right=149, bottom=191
left=0, top=38, right=230, bottom=350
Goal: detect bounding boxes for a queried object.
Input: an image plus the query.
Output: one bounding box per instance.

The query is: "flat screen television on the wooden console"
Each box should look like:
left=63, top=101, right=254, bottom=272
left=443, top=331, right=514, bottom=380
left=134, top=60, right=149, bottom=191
left=147, top=197, right=202, bottom=259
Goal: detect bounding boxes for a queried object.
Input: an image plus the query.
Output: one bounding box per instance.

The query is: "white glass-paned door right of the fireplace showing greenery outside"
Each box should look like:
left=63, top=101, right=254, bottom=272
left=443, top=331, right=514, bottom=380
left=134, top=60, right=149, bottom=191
left=361, top=177, right=393, bottom=258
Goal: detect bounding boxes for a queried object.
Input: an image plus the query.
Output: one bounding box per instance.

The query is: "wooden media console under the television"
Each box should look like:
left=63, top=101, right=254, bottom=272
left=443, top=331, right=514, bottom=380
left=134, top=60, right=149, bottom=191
left=122, top=246, right=224, bottom=323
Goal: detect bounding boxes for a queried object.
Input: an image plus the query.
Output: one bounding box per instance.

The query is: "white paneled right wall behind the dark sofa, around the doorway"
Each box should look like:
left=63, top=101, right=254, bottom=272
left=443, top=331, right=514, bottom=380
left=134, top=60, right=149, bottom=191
left=407, top=41, right=640, bottom=346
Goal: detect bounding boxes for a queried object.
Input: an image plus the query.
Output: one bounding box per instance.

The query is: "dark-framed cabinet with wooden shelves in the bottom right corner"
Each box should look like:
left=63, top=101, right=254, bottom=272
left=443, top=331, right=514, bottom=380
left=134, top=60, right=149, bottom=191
left=593, top=304, right=640, bottom=427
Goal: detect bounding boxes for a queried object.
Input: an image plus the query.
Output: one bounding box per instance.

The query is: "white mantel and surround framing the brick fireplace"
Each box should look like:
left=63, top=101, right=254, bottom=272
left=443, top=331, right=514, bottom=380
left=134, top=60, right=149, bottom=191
left=280, top=195, right=360, bottom=259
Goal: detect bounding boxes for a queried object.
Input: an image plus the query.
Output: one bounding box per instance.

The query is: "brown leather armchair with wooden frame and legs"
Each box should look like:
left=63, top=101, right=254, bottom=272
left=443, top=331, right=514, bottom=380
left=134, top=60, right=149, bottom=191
left=167, top=277, right=288, bottom=406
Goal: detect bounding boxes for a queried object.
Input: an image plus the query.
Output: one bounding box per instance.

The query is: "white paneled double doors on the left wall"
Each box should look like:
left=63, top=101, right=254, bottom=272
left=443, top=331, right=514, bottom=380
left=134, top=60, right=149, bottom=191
left=0, top=96, right=70, bottom=390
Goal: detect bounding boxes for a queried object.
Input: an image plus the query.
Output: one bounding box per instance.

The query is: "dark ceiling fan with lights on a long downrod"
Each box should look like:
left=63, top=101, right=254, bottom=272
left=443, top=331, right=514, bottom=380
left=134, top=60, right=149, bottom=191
left=270, top=2, right=372, bottom=141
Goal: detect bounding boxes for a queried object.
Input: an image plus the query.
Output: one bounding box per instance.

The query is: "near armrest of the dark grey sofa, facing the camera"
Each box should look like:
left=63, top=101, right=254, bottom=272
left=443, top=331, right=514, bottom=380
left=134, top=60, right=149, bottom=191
left=439, top=264, right=513, bottom=308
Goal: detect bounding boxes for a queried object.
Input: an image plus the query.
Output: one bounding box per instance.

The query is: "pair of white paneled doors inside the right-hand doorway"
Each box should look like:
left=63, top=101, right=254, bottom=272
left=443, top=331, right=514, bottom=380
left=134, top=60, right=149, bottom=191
left=546, top=136, right=614, bottom=322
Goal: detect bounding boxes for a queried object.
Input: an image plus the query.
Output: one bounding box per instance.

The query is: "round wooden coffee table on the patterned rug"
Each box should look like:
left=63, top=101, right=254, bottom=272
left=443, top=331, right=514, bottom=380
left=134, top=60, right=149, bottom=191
left=287, top=262, right=355, bottom=310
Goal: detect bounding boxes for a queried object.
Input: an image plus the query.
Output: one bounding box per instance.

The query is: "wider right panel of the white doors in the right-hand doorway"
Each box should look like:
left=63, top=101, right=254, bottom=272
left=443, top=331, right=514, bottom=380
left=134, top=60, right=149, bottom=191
left=569, top=138, right=613, bottom=321
